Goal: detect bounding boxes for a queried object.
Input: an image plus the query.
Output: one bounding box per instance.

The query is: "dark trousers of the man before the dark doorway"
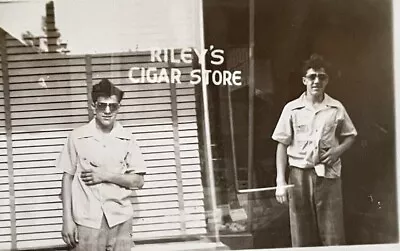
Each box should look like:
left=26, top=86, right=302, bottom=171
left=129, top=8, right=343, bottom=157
left=288, top=167, right=345, bottom=247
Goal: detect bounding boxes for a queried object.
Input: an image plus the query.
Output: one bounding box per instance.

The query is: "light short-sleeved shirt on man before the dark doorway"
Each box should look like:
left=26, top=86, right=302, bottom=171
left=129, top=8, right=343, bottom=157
left=272, top=93, right=357, bottom=178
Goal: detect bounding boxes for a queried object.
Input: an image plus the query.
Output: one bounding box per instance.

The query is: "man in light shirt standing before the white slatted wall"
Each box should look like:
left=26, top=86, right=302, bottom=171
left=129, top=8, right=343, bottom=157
left=57, top=79, right=146, bottom=251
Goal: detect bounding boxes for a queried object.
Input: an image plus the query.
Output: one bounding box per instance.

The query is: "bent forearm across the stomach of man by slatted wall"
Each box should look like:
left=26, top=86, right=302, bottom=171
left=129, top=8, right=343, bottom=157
left=81, top=168, right=144, bottom=189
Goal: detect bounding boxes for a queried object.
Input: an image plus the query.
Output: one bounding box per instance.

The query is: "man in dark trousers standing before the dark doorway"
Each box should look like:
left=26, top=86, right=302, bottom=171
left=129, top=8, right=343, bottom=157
left=272, top=54, right=357, bottom=247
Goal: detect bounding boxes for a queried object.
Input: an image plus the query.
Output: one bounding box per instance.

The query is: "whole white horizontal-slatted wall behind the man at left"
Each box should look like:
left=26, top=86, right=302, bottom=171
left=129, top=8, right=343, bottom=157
left=0, top=47, right=205, bottom=247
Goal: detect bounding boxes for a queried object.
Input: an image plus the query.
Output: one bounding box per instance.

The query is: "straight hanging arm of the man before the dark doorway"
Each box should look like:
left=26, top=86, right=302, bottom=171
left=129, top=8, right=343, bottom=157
left=275, top=143, right=287, bottom=203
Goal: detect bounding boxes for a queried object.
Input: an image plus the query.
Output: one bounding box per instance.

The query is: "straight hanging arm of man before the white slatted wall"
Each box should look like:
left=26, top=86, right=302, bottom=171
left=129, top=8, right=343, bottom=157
left=61, top=173, right=78, bottom=247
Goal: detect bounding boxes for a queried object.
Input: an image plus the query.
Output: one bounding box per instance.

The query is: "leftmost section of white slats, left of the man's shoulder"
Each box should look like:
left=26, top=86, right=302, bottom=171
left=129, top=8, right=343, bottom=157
left=9, top=52, right=88, bottom=248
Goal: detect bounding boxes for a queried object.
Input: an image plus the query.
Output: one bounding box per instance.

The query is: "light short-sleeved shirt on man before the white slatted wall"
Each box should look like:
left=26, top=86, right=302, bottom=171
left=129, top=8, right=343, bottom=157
left=57, top=119, right=146, bottom=229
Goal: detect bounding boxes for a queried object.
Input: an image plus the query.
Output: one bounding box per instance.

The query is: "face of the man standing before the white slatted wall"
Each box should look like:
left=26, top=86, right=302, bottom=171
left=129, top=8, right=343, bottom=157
left=93, top=95, right=119, bottom=128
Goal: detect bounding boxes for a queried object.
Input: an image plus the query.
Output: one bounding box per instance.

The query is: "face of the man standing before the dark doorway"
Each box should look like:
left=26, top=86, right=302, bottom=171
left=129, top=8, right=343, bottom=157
left=303, top=68, right=329, bottom=96
